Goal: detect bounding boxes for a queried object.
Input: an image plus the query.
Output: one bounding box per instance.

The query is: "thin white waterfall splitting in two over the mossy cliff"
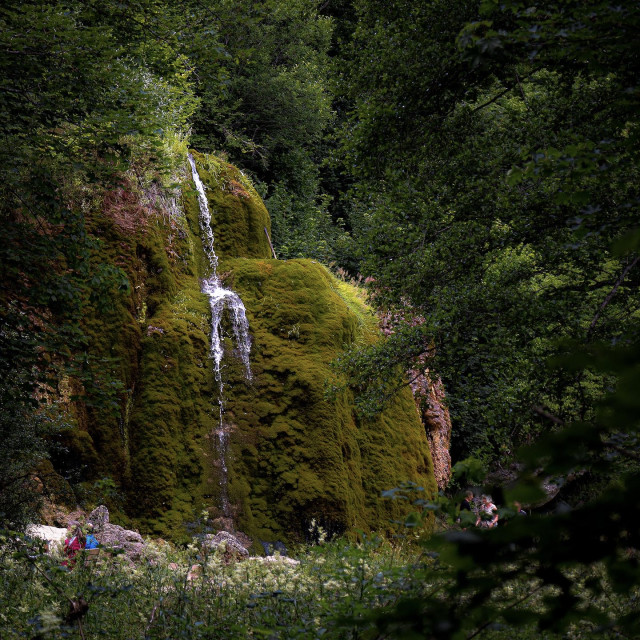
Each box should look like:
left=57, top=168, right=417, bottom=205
left=188, top=154, right=252, bottom=517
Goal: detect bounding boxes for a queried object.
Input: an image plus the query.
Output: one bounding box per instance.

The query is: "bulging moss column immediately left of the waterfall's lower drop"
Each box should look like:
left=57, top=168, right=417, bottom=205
left=125, top=248, right=217, bottom=535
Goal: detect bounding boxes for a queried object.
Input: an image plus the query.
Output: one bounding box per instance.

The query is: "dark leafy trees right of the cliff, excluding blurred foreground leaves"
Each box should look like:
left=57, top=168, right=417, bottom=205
left=342, top=2, right=640, bottom=458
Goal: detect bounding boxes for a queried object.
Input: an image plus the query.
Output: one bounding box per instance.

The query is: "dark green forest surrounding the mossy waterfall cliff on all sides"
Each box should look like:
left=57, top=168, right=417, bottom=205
left=0, top=0, right=640, bottom=638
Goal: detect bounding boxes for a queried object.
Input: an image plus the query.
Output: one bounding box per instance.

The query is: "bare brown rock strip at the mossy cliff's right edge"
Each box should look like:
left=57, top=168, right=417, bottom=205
left=409, top=369, right=451, bottom=489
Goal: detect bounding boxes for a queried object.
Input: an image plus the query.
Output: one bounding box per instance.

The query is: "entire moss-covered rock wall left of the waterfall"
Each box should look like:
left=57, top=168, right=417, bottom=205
left=62, top=169, right=222, bottom=538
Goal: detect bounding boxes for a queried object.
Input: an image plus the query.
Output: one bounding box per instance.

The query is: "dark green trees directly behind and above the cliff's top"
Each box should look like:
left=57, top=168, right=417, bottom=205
left=176, top=0, right=337, bottom=260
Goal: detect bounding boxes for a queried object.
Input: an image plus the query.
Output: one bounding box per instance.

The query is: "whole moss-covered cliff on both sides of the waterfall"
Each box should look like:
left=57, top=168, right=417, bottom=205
left=64, top=154, right=436, bottom=540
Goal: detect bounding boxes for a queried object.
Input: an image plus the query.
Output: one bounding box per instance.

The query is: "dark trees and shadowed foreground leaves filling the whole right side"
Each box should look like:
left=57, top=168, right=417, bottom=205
left=336, top=1, right=640, bottom=638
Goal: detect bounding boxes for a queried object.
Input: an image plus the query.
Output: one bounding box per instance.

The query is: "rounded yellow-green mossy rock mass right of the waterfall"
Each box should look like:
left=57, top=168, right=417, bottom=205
left=221, top=259, right=435, bottom=540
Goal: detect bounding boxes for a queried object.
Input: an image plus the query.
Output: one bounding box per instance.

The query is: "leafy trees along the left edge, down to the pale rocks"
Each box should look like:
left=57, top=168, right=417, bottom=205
left=0, top=0, right=194, bottom=523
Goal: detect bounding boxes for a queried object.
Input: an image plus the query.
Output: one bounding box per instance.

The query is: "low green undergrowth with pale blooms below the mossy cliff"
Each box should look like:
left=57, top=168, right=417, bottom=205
left=0, top=531, right=624, bottom=640
